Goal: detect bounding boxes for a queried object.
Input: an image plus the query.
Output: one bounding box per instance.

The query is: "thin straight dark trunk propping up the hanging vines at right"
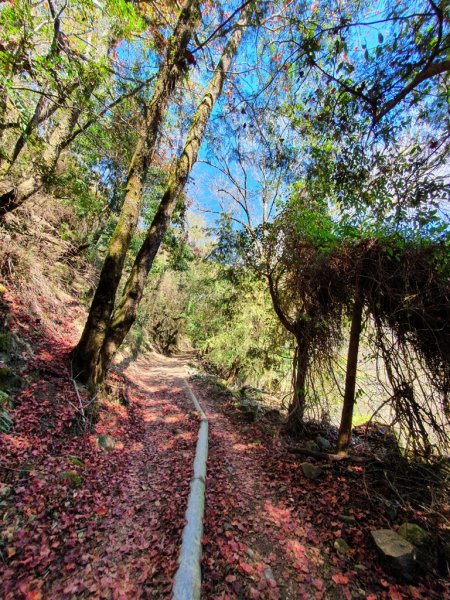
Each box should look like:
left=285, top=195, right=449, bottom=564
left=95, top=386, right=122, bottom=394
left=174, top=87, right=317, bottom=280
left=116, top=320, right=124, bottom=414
left=336, top=275, right=364, bottom=455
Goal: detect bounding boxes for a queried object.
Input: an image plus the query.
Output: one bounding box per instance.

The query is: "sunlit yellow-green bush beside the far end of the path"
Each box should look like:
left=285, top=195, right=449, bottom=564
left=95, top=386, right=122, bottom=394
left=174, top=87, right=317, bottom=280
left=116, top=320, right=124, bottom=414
left=185, top=261, right=291, bottom=389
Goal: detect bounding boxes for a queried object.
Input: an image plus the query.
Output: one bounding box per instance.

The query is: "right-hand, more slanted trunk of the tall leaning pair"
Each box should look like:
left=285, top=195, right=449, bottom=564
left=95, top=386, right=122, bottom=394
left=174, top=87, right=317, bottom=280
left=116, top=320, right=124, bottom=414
left=91, top=8, right=252, bottom=386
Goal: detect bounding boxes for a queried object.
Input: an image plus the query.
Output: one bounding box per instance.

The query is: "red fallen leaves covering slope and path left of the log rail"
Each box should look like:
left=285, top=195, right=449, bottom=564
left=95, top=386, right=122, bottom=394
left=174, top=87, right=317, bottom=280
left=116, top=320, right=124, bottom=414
left=0, top=290, right=197, bottom=600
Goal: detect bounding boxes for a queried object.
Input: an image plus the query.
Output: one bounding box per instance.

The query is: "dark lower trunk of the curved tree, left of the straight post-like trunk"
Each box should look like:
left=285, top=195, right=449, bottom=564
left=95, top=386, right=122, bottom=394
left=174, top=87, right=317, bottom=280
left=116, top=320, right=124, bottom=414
left=286, top=336, right=309, bottom=434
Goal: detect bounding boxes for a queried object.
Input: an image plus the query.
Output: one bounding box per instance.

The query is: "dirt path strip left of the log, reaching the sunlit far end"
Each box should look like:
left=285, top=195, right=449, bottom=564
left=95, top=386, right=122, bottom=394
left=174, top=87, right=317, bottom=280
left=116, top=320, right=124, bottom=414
left=65, top=355, right=197, bottom=600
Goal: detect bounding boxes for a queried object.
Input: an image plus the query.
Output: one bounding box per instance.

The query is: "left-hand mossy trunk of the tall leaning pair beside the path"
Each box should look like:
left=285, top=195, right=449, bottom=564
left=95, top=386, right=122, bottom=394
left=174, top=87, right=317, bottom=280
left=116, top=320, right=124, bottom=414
left=72, top=0, right=200, bottom=382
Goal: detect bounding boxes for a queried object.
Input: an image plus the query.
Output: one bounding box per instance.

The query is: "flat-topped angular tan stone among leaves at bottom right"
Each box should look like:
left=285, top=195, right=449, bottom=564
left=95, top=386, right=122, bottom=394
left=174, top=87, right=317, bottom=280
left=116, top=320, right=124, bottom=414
left=370, top=529, right=416, bottom=580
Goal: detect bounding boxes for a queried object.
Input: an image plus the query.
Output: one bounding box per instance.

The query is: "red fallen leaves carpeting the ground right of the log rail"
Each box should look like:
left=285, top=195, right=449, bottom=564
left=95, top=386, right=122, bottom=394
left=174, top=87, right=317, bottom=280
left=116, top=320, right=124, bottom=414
left=195, top=384, right=445, bottom=600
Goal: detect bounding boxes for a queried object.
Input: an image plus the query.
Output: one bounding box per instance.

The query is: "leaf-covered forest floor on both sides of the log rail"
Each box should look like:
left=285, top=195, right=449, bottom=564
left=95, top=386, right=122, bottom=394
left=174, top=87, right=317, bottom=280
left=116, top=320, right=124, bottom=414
left=0, top=294, right=445, bottom=600
